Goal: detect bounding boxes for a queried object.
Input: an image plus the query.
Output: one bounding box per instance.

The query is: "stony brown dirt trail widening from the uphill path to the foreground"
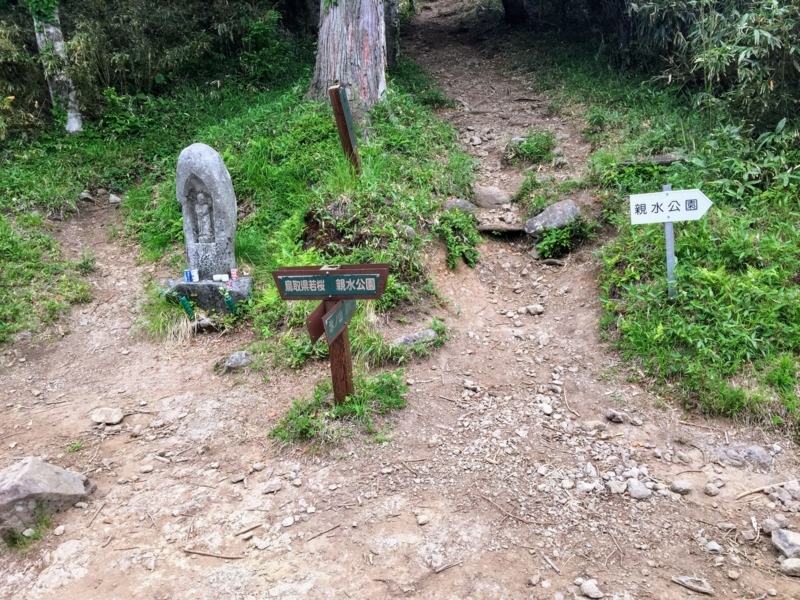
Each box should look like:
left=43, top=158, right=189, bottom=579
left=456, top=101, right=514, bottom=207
left=0, top=1, right=800, bottom=600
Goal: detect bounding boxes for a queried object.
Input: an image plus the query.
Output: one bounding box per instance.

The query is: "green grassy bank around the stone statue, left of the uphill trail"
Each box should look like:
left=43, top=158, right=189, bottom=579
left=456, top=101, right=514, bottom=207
left=0, top=54, right=480, bottom=358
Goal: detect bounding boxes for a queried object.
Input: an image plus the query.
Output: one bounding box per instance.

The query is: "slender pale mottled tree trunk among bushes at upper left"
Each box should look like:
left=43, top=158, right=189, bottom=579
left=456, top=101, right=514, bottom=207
left=33, top=8, right=83, bottom=133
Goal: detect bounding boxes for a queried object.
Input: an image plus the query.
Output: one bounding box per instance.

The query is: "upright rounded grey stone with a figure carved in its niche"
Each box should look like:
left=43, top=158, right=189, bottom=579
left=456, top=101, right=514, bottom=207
left=180, top=144, right=241, bottom=280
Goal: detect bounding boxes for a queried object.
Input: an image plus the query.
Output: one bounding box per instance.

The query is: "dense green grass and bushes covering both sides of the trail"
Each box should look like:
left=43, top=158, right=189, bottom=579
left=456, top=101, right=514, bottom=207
left=0, top=0, right=800, bottom=432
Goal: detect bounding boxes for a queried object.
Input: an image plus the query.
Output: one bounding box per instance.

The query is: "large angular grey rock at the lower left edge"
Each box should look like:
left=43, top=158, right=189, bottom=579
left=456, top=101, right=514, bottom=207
left=0, top=456, right=95, bottom=540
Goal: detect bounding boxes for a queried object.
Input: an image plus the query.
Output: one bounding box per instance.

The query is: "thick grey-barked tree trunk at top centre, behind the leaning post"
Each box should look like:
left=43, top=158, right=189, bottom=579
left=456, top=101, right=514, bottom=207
left=308, top=0, right=386, bottom=119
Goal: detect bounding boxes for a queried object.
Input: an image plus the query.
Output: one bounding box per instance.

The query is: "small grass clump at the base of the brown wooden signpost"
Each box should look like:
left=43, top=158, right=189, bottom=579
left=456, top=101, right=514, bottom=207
left=269, top=371, right=408, bottom=444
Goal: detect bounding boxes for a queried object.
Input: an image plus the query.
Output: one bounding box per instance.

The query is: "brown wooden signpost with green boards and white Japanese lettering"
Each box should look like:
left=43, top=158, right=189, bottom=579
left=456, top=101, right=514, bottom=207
left=272, top=264, right=389, bottom=404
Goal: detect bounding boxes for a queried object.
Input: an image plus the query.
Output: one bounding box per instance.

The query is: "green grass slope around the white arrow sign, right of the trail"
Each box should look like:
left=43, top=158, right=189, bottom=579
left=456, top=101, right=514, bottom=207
left=526, top=32, right=800, bottom=427
